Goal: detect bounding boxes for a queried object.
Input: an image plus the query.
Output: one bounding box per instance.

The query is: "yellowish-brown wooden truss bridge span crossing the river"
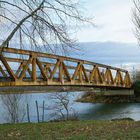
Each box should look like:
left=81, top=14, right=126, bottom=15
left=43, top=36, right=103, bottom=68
left=0, top=48, right=132, bottom=92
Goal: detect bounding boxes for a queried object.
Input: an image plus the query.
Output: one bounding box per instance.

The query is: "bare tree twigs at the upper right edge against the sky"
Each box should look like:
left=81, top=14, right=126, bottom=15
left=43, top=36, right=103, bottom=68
left=133, top=0, right=140, bottom=44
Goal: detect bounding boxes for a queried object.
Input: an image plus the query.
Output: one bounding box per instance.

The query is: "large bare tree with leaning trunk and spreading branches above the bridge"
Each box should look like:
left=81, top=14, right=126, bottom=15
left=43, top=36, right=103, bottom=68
left=0, top=0, right=89, bottom=52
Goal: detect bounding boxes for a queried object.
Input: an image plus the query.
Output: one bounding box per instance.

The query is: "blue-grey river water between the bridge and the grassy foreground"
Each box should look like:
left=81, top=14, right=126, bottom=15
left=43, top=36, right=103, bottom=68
left=0, top=92, right=140, bottom=123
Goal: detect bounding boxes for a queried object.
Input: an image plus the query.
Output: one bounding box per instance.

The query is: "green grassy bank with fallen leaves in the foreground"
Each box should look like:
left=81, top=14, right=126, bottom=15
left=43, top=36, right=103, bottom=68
left=0, top=120, right=140, bottom=140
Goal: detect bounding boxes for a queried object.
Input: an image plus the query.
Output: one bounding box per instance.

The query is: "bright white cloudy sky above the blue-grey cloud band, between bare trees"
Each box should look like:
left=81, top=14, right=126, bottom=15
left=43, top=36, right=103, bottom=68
left=77, top=0, right=137, bottom=43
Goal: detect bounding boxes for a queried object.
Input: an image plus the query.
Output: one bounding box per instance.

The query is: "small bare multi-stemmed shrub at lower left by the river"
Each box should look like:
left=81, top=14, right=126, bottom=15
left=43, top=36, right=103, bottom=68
left=1, top=94, right=27, bottom=123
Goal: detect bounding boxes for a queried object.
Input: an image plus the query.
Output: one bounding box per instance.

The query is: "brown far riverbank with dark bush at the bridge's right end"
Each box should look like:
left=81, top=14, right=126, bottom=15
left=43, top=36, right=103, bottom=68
left=76, top=80, right=140, bottom=103
